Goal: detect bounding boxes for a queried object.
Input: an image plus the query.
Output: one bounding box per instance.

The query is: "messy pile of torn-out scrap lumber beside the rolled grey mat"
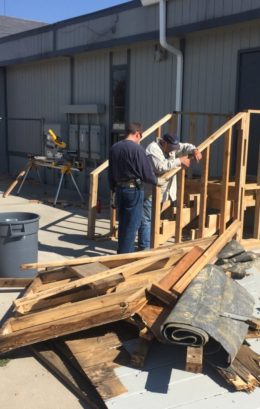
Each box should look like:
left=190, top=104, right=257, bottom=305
left=0, top=221, right=260, bottom=408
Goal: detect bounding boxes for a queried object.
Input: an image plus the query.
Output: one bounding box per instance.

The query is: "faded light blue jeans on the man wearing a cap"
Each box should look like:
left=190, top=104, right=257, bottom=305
left=138, top=198, right=152, bottom=250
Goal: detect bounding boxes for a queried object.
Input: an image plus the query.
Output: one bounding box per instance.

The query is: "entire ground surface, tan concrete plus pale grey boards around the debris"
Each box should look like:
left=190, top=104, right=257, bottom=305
left=0, top=179, right=260, bottom=409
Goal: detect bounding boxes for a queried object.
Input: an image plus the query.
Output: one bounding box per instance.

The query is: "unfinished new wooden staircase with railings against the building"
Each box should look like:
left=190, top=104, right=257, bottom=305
left=88, top=110, right=260, bottom=247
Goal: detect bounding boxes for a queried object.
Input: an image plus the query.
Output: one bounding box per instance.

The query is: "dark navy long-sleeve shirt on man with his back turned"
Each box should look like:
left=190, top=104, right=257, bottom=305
left=108, top=139, right=157, bottom=190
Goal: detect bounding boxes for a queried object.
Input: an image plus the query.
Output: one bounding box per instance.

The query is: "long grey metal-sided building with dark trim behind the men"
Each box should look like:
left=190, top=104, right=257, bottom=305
left=0, top=0, right=260, bottom=191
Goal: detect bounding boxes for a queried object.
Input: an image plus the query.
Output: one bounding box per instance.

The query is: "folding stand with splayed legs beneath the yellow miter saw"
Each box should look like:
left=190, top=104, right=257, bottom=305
left=14, top=157, right=85, bottom=206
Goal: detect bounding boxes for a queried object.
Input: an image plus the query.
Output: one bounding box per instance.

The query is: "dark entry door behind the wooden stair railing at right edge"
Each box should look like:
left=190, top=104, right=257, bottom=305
left=237, top=50, right=260, bottom=175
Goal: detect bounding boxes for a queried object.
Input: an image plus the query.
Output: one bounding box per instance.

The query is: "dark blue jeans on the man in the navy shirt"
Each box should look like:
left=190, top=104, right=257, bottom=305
left=116, top=187, right=144, bottom=254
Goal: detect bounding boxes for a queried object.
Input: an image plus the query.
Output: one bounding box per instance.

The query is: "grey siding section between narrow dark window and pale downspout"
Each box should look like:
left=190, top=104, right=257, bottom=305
left=130, top=43, right=176, bottom=139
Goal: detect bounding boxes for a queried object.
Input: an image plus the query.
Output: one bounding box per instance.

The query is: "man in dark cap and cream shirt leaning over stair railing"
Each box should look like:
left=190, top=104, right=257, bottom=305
left=138, top=133, right=202, bottom=250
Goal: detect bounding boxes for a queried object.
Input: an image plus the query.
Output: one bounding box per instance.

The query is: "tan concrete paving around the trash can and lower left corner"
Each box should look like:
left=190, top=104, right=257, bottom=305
left=0, top=180, right=116, bottom=409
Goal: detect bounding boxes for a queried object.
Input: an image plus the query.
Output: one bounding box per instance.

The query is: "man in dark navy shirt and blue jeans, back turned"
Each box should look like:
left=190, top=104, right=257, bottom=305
left=108, top=122, right=162, bottom=253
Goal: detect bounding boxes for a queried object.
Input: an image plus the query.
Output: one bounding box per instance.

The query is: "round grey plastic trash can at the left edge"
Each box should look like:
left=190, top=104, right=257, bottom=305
left=0, top=212, right=39, bottom=277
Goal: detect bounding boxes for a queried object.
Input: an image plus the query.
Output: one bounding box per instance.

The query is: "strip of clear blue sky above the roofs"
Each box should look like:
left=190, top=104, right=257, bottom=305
left=0, top=0, right=129, bottom=23
